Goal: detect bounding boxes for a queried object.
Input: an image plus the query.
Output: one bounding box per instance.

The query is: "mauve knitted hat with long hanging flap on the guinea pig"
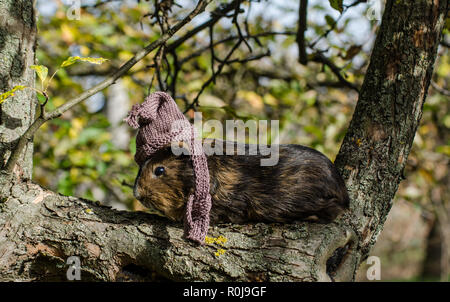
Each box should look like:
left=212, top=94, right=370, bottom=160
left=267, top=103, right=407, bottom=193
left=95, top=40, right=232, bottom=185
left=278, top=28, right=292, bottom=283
left=124, top=92, right=211, bottom=244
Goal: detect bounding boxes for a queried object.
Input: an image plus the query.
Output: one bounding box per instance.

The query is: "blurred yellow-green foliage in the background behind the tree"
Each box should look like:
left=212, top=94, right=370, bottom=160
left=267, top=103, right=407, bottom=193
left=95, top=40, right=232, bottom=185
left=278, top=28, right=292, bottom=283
left=34, top=0, right=450, bottom=280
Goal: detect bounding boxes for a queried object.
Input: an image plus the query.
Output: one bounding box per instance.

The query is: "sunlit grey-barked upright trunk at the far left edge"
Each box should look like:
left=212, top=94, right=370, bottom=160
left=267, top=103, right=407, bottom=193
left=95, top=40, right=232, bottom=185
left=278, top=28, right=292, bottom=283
left=0, top=0, right=36, bottom=178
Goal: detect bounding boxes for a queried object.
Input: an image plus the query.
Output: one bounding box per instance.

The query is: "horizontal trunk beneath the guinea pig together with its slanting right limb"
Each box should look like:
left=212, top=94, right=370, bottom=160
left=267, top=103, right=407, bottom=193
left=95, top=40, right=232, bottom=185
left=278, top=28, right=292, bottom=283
left=0, top=0, right=448, bottom=281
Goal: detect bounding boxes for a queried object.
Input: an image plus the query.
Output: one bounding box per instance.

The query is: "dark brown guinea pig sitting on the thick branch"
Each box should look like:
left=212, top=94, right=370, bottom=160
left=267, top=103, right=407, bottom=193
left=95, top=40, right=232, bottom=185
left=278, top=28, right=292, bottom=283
left=134, top=140, right=349, bottom=224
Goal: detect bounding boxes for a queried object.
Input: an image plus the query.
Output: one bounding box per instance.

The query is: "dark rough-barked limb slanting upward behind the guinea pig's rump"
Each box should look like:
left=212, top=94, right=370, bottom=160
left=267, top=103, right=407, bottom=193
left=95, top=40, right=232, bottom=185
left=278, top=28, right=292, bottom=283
left=335, top=0, right=448, bottom=259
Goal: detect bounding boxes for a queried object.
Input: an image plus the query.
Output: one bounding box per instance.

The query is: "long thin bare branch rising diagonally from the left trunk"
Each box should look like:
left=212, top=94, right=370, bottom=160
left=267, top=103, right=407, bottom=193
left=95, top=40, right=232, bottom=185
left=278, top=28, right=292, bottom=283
left=5, top=0, right=212, bottom=172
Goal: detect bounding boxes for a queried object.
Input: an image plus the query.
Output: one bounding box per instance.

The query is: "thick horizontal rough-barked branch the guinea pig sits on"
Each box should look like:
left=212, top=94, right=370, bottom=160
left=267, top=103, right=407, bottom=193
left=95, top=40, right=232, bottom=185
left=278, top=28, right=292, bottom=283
left=0, top=173, right=357, bottom=281
